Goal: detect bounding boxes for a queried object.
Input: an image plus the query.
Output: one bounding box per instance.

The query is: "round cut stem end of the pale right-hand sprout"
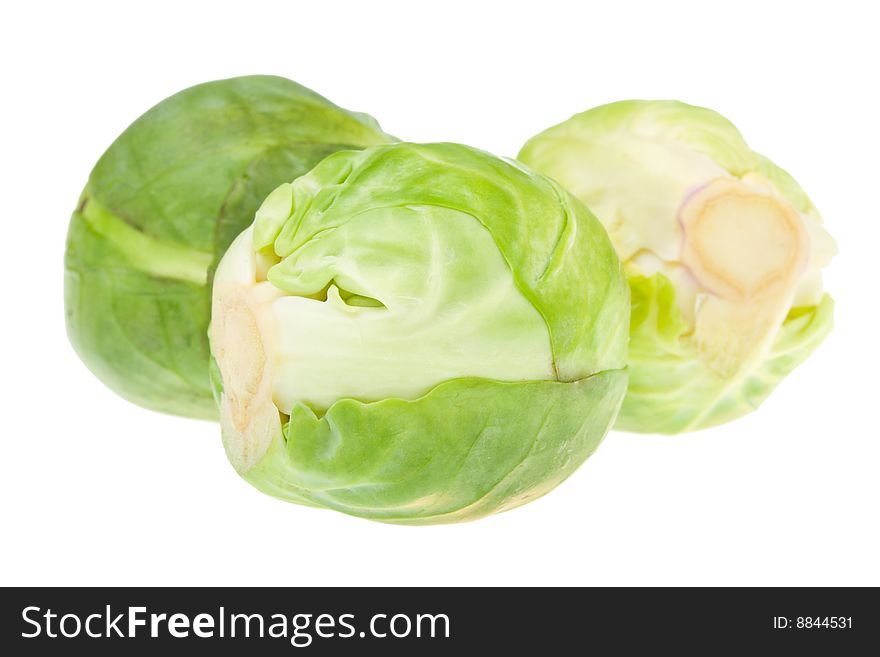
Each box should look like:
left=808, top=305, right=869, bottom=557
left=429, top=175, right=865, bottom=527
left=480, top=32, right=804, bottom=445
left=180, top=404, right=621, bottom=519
left=679, top=178, right=810, bottom=376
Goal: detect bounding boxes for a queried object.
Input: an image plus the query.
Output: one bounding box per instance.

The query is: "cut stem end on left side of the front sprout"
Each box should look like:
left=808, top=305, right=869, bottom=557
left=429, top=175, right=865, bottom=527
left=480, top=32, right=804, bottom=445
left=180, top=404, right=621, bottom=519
left=211, top=283, right=281, bottom=474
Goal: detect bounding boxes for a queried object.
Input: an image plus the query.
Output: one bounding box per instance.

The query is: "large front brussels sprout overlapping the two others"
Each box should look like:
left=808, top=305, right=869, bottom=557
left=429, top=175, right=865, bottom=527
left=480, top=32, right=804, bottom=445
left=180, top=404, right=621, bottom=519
left=210, top=143, right=629, bottom=523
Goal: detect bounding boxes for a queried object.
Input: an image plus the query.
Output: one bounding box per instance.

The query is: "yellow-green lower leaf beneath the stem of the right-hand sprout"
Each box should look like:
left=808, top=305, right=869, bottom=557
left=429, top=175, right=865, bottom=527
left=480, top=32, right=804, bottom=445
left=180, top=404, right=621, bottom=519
left=615, top=274, right=834, bottom=434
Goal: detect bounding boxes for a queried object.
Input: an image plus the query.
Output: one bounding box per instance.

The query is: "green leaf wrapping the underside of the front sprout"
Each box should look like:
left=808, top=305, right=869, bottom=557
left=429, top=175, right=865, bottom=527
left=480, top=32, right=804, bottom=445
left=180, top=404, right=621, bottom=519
left=244, top=370, right=626, bottom=524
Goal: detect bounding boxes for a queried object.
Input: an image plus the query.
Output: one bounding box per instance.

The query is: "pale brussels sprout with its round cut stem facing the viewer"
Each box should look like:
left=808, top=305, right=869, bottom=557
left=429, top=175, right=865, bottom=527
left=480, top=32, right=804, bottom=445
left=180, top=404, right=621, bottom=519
left=519, top=101, right=836, bottom=433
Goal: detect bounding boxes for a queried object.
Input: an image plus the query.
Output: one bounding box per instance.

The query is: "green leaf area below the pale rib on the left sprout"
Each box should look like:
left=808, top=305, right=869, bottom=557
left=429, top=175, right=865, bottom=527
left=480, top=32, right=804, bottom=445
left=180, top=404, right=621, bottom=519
left=64, top=212, right=217, bottom=419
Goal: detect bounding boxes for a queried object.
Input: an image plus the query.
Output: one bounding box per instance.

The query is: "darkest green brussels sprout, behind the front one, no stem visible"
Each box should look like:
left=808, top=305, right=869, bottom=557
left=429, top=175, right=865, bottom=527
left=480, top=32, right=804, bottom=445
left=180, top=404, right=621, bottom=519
left=65, top=76, right=389, bottom=418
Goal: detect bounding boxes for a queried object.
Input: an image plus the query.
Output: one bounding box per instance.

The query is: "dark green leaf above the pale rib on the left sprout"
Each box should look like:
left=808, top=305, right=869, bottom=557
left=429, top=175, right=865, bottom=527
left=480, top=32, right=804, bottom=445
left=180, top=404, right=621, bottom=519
left=90, top=75, right=389, bottom=251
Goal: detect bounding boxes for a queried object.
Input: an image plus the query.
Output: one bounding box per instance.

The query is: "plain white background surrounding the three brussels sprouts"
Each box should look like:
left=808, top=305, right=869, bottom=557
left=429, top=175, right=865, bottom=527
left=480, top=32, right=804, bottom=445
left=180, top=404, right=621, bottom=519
left=0, top=0, right=880, bottom=585
